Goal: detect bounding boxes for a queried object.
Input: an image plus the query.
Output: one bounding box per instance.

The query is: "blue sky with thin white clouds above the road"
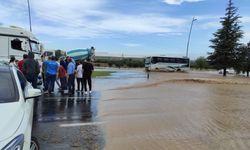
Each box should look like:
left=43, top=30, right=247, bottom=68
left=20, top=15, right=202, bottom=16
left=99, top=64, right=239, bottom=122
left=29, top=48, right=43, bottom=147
left=0, top=0, right=250, bottom=58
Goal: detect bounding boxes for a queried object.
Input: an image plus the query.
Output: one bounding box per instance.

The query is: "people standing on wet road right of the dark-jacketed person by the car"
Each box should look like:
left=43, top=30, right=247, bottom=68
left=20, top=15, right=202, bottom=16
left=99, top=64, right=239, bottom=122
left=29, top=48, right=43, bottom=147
left=42, top=56, right=94, bottom=94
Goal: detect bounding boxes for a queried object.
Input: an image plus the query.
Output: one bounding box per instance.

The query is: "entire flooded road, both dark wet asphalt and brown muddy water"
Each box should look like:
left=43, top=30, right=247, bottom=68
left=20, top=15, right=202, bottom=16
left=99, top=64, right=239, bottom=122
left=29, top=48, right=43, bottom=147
left=33, top=70, right=250, bottom=150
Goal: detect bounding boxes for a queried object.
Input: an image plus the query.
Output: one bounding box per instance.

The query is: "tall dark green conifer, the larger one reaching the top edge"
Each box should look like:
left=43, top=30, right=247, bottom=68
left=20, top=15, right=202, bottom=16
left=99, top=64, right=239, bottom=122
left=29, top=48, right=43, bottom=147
left=208, top=0, right=243, bottom=76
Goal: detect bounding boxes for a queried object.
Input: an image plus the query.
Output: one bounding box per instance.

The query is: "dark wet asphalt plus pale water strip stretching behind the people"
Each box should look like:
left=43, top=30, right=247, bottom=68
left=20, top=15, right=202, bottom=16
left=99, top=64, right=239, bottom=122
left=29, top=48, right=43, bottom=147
left=32, top=70, right=145, bottom=150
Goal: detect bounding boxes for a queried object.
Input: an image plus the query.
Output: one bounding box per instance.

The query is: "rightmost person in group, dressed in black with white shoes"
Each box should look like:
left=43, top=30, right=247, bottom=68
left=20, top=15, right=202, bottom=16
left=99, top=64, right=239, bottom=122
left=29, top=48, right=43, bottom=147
left=82, top=58, right=94, bottom=94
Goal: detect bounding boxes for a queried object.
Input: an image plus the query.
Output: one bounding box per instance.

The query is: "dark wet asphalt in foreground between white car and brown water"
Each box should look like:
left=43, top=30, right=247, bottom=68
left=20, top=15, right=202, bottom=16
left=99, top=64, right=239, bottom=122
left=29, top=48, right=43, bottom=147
left=33, top=92, right=105, bottom=150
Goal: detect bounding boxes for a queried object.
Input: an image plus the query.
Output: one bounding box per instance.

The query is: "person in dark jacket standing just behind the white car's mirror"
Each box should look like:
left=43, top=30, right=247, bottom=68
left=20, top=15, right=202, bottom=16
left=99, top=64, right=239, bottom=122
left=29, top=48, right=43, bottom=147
left=23, top=52, right=40, bottom=88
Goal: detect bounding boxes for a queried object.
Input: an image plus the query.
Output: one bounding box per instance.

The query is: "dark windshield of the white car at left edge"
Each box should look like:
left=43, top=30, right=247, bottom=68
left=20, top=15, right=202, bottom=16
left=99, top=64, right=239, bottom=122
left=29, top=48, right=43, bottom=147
left=0, top=72, right=18, bottom=103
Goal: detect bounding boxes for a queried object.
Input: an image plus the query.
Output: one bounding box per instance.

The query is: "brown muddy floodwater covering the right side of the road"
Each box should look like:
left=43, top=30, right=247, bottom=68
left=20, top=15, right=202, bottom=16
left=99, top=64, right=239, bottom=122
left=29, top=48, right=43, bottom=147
left=98, top=72, right=250, bottom=150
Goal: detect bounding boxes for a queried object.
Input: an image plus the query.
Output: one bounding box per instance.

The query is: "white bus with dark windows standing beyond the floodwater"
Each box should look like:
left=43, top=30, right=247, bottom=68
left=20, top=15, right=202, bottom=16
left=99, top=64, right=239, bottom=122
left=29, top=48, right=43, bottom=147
left=145, top=56, right=190, bottom=72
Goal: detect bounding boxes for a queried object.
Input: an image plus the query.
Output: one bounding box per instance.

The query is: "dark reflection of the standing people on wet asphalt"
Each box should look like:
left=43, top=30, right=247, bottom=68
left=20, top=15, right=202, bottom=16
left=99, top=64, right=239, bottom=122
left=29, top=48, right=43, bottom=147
left=34, top=93, right=99, bottom=122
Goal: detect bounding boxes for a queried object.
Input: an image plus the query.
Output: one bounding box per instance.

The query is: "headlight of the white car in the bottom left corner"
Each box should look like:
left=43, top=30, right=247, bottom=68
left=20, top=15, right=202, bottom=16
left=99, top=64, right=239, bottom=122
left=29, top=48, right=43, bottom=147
left=2, top=134, right=24, bottom=150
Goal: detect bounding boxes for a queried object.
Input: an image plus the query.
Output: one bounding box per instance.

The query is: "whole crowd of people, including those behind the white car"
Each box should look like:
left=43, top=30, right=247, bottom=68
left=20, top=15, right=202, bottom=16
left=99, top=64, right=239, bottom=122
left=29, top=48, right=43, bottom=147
left=9, top=52, right=94, bottom=94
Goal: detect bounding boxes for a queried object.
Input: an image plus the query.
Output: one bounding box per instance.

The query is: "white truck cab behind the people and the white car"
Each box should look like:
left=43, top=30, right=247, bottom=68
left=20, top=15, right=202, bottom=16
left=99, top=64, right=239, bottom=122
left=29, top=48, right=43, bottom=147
left=0, top=27, right=41, bottom=61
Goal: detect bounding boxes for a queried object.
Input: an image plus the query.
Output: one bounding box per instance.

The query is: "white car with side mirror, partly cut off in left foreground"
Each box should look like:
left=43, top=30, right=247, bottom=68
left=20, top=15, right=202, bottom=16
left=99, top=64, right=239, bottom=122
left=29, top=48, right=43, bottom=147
left=0, top=64, right=41, bottom=150
